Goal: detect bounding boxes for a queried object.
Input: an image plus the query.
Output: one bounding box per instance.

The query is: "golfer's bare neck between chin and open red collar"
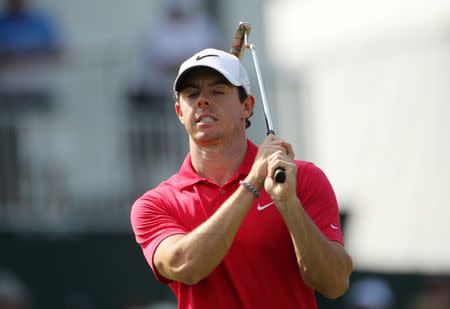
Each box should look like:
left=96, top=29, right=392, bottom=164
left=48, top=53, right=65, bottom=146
left=190, top=136, right=247, bottom=186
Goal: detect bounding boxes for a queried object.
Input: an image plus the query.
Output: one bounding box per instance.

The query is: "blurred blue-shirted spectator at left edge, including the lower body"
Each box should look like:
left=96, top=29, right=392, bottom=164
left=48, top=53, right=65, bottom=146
left=0, top=0, right=61, bottom=204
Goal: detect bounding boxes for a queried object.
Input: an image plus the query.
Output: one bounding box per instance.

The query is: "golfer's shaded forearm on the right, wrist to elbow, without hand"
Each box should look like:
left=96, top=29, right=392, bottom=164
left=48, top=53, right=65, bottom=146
left=278, top=197, right=353, bottom=298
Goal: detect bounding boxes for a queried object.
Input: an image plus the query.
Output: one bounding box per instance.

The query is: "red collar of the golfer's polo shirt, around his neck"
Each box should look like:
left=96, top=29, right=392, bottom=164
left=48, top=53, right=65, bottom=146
left=177, top=140, right=258, bottom=190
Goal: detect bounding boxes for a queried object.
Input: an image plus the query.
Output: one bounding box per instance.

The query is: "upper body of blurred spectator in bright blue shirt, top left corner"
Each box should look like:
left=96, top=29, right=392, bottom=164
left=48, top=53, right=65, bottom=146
left=0, top=0, right=61, bottom=102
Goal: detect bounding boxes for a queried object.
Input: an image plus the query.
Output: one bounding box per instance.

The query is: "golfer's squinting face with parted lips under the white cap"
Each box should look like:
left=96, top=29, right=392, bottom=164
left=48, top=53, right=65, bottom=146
left=175, top=68, right=254, bottom=146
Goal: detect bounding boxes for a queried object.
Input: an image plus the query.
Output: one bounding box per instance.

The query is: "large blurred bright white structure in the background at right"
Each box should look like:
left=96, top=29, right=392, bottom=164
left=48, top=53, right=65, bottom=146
left=266, top=0, right=450, bottom=273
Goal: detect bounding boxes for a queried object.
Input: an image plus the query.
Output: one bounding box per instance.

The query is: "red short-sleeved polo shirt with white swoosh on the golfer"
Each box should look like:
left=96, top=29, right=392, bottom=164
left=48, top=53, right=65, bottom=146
left=131, top=141, right=342, bottom=309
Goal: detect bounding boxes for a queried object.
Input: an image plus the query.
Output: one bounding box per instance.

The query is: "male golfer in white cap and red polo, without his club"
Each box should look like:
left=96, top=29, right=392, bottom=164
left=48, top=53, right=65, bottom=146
left=131, top=49, right=352, bottom=309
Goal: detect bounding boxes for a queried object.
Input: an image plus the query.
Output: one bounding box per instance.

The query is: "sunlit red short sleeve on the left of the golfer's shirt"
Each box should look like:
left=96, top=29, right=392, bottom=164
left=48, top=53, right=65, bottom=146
left=131, top=191, right=187, bottom=283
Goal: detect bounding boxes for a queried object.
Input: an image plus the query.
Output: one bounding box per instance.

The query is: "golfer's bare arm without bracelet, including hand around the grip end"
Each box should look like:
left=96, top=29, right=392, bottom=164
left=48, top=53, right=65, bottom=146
left=265, top=139, right=353, bottom=298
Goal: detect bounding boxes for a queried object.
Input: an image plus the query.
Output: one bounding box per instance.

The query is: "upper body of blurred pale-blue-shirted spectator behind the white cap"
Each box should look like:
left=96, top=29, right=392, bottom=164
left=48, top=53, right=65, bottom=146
left=130, top=0, right=219, bottom=108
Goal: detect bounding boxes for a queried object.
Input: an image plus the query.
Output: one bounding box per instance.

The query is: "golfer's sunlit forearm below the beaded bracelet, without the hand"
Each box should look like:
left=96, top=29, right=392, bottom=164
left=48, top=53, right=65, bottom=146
left=163, top=174, right=262, bottom=284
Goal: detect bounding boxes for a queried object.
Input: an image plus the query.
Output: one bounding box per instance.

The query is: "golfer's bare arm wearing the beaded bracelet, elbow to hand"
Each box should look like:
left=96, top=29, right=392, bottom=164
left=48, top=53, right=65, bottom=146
left=153, top=142, right=282, bottom=285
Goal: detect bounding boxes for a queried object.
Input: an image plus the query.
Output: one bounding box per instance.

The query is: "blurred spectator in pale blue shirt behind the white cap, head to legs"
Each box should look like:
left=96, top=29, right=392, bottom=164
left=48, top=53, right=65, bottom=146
left=128, top=0, right=220, bottom=192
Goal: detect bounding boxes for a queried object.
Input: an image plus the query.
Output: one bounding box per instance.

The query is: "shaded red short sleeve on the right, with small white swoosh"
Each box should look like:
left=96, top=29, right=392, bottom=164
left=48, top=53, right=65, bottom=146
left=297, top=162, right=344, bottom=244
